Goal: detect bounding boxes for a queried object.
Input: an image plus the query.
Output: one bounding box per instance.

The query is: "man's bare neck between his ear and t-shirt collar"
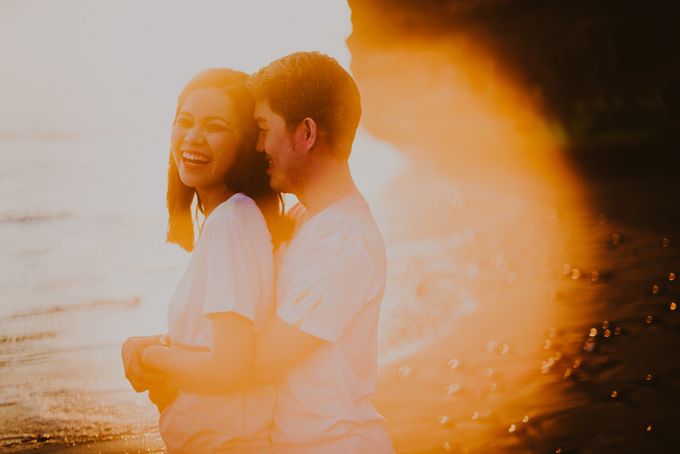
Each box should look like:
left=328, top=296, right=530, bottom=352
left=295, top=160, right=360, bottom=215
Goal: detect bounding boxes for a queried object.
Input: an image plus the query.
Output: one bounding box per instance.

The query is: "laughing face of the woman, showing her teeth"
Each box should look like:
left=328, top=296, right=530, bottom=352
left=172, top=88, right=240, bottom=191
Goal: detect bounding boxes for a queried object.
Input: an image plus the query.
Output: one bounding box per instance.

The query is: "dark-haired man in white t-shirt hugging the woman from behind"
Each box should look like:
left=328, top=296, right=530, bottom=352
left=252, top=52, right=393, bottom=453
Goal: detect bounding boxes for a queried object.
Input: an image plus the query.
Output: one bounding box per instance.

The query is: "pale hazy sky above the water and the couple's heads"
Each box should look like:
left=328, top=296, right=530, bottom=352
left=0, top=0, right=351, bottom=132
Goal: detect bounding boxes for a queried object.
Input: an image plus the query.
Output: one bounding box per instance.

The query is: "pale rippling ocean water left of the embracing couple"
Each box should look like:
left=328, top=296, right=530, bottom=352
left=0, top=133, right=187, bottom=449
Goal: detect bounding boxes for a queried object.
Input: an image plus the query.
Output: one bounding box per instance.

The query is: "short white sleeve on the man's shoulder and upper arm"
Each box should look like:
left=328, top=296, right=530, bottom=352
left=277, top=235, right=384, bottom=342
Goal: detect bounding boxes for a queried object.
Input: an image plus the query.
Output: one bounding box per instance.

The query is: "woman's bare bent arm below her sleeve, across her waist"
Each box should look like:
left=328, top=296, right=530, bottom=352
left=142, top=312, right=255, bottom=394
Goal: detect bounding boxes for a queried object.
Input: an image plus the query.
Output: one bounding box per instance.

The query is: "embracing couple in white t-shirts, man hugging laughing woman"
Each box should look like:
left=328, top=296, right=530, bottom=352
left=122, top=52, right=393, bottom=453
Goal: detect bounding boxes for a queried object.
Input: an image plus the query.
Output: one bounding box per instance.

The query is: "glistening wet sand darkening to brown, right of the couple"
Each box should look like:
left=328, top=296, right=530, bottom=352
left=376, top=165, right=680, bottom=453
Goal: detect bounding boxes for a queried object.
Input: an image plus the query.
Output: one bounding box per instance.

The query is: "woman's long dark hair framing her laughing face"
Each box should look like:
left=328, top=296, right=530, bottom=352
left=166, top=68, right=288, bottom=252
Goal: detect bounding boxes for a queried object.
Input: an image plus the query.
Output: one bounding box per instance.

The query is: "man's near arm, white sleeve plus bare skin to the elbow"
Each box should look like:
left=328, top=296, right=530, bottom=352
left=253, top=233, right=374, bottom=384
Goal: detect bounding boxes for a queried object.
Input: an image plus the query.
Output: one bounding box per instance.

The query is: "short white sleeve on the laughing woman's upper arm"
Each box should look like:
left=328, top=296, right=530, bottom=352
left=194, top=200, right=271, bottom=322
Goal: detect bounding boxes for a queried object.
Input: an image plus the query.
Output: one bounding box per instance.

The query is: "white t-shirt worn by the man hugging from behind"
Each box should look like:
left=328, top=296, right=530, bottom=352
left=272, top=195, right=393, bottom=453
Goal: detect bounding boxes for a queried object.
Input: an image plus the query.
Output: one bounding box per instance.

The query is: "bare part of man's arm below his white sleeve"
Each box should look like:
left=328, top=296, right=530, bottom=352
left=253, top=313, right=327, bottom=384
